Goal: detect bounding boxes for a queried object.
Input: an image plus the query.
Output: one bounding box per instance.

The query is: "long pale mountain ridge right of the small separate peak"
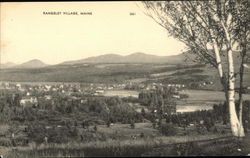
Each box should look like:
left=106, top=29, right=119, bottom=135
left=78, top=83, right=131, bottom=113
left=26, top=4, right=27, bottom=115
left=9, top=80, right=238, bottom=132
left=61, top=53, right=189, bottom=65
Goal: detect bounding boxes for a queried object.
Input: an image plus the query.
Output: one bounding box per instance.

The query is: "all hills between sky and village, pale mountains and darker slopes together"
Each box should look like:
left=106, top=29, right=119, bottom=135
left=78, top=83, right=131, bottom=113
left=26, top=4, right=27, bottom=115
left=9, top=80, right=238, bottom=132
left=0, top=53, right=250, bottom=88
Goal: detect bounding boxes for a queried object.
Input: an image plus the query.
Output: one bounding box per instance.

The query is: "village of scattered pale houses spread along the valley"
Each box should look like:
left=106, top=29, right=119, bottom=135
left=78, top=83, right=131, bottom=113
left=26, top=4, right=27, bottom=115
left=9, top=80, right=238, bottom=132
left=0, top=82, right=185, bottom=107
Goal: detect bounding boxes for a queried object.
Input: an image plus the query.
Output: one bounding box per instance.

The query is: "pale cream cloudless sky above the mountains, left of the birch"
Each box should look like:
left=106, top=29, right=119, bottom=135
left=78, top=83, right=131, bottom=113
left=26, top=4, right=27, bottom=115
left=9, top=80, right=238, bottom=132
left=0, top=1, right=185, bottom=64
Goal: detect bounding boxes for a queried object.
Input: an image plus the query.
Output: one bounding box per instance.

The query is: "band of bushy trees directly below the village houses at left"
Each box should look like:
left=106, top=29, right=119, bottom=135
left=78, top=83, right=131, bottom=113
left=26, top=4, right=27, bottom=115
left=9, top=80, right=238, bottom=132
left=0, top=89, right=143, bottom=123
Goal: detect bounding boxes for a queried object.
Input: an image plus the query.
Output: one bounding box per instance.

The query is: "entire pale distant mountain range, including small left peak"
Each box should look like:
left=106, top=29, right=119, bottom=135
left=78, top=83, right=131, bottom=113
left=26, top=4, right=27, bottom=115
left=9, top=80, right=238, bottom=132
left=1, top=53, right=191, bottom=69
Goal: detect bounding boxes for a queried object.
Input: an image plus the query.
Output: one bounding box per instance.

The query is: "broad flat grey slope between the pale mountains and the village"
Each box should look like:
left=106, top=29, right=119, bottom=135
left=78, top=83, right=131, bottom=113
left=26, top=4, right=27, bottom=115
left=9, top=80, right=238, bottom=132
left=0, top=63, right=216, bottom=83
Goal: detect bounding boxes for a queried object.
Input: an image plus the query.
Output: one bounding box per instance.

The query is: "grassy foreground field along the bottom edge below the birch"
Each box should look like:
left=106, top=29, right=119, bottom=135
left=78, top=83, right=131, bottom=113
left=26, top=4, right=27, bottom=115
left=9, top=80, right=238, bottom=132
left=6, top=135, right=249, bottom=158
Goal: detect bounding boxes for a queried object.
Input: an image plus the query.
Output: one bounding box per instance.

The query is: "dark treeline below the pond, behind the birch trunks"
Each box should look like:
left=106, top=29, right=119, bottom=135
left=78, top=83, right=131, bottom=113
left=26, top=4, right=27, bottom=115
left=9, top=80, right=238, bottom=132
left=162, top=100, right=250, bottom=135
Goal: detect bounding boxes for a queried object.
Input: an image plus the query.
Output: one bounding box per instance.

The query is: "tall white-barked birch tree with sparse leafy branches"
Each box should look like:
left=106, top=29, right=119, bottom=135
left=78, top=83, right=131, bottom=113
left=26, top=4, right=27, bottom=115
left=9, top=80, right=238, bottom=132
left=143, top=0, right=249, bottom=137
